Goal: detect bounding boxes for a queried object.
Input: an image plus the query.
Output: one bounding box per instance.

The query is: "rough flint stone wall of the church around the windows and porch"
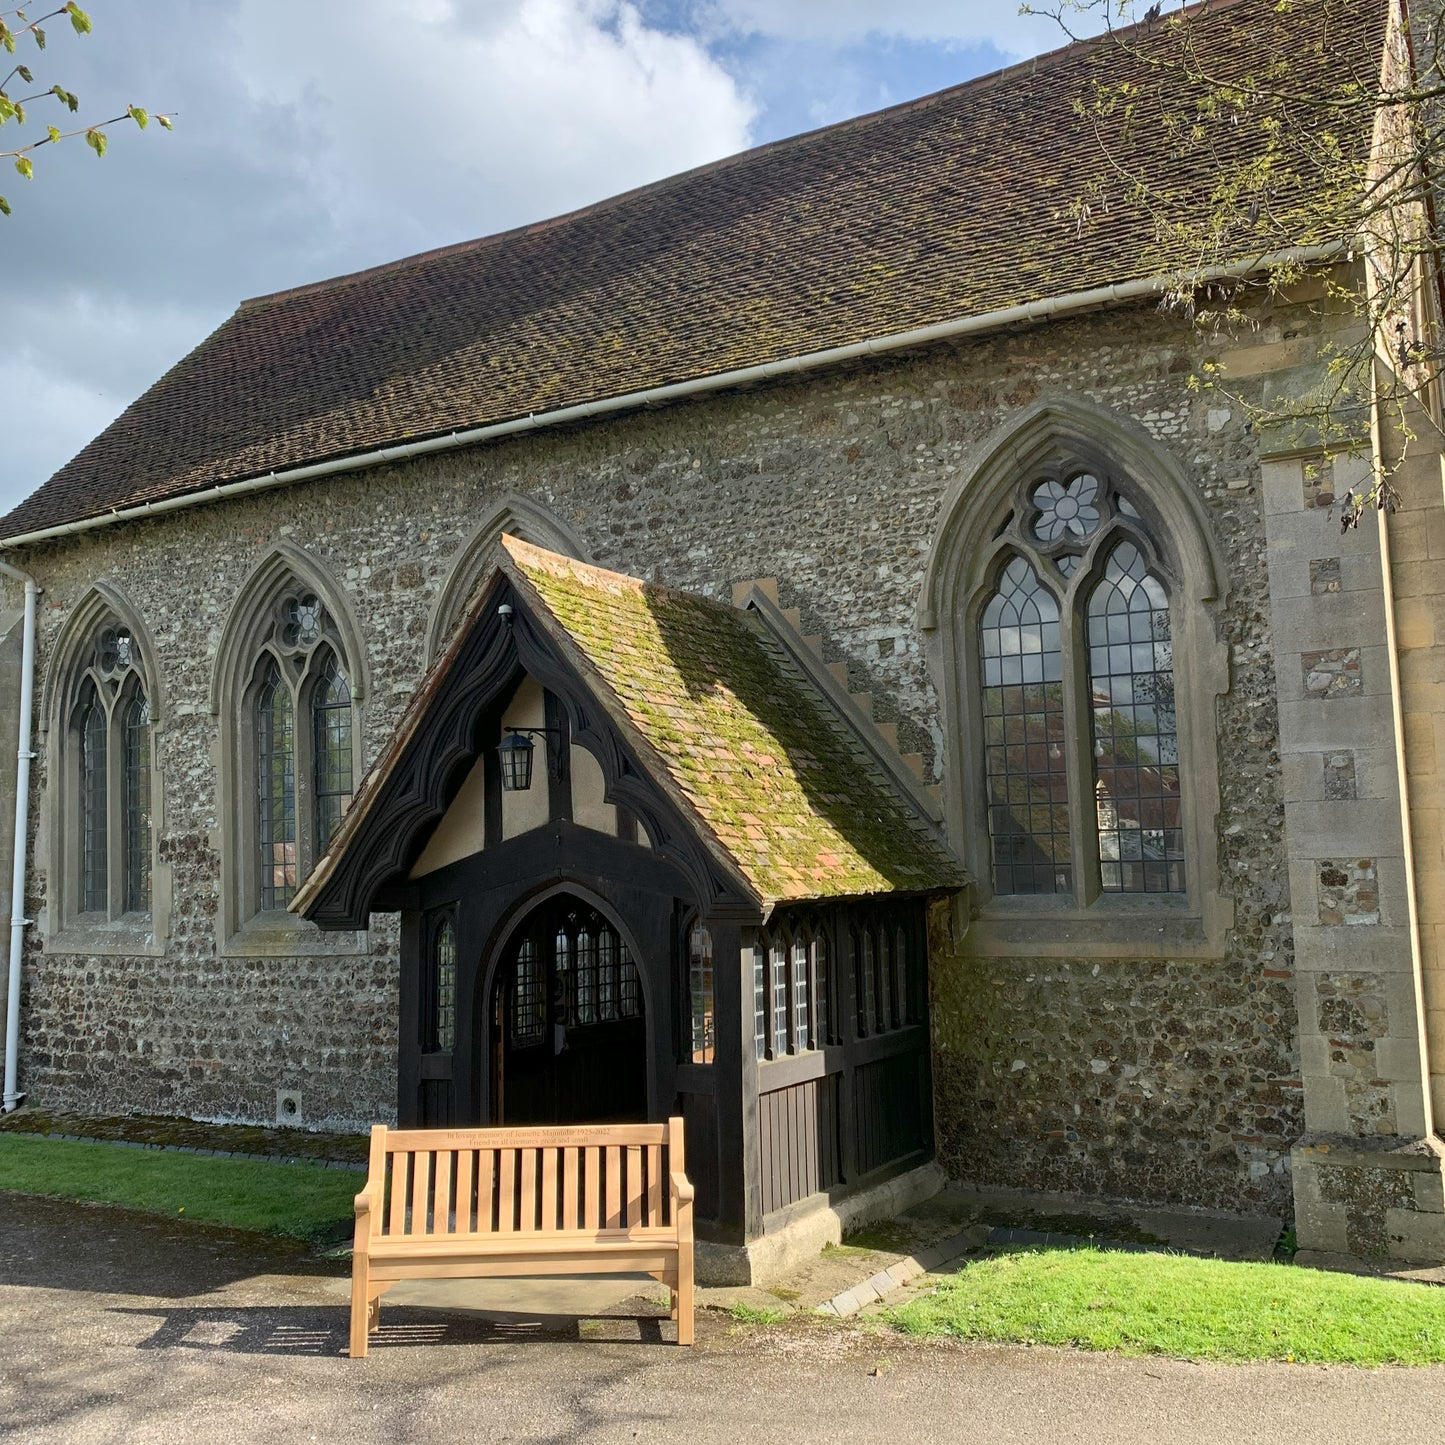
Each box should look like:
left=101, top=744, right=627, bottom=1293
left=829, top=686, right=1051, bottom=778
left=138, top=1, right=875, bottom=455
left=8, top=308, right=1301, bottom=1207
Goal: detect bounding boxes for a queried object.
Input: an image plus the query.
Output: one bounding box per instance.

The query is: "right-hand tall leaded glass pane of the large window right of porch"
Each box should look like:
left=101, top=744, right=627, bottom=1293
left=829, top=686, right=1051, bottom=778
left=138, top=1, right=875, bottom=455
left=1088, top=542, right=1185, bottom=893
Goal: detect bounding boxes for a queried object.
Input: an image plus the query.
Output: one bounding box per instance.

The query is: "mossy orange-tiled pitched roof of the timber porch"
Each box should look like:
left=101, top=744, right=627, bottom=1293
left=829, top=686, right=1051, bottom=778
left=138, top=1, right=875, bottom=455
left=290, top=536, right=965, bottom=912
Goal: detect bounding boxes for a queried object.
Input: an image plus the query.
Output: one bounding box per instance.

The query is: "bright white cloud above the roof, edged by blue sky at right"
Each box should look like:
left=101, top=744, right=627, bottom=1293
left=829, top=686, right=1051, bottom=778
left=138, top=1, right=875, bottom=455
left=228, top=0, right=753, bottom=260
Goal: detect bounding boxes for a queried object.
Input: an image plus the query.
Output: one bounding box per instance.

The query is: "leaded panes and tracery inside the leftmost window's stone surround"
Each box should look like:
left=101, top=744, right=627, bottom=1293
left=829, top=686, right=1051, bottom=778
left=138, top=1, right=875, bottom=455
left=58, top=620, right=153, bottom=922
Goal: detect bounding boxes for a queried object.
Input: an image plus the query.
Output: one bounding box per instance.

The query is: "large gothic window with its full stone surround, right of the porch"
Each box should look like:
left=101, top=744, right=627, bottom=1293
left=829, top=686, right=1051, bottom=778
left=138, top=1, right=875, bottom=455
left=924, top=396, right=1234, bottom=953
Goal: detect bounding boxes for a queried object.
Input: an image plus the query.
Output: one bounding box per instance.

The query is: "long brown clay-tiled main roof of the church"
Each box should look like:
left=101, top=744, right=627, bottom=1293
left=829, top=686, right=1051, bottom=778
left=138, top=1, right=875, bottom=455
left=0, top=0, right=1386, bottom=539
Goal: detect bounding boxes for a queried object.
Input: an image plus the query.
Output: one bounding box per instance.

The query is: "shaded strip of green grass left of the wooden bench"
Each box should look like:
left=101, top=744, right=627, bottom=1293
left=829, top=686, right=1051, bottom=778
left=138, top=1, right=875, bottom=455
left=0, top=1134, right=366, bottom=1240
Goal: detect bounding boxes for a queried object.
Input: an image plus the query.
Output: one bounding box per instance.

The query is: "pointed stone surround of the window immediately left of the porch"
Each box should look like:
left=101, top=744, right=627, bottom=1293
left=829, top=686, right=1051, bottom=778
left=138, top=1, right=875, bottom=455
left=211, top=542, right=371, bottom=958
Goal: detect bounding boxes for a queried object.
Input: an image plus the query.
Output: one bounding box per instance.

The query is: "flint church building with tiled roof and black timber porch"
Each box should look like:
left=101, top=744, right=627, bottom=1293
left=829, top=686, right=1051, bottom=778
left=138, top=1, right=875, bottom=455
left=0, top=0, right=1445, bottom=1280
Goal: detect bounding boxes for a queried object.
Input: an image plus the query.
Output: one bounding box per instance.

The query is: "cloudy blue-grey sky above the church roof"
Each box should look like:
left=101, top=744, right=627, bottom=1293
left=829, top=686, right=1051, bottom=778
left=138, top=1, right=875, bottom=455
left=0, top=0, right=1109, bottom=513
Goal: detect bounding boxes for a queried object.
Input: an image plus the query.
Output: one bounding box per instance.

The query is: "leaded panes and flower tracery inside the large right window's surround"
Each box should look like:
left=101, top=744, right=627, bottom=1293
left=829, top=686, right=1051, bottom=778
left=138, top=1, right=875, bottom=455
left=975, top=470, right=1188, bottom=903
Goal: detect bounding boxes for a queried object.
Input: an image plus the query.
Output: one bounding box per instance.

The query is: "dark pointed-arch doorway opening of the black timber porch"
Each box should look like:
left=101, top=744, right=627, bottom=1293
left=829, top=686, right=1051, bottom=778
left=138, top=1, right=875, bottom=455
left=484, top=893, right=647, bottom=1124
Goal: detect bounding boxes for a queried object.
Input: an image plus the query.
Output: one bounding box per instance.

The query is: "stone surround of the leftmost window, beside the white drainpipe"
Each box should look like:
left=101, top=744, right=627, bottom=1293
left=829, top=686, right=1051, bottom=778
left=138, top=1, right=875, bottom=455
left=36, top=581, right=171, bottom=958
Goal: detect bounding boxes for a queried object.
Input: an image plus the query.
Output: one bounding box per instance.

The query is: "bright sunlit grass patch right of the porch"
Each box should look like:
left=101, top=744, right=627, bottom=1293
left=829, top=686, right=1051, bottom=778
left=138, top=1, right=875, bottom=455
left=884, top=1248, right=1445, bottom=1364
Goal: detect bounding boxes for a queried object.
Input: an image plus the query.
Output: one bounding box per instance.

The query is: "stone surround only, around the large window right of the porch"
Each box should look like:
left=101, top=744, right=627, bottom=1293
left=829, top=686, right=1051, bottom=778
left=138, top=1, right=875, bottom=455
left=919, top=396, right=1234, bottom=959
